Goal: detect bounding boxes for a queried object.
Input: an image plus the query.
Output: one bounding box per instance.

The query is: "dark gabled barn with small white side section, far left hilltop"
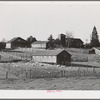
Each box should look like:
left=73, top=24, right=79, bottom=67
left=6, top=37, right=29, bottom=48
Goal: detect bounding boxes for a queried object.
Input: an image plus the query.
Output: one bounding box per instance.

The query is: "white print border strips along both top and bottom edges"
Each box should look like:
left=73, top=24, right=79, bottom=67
left=0, top=1, right=100, bottom=99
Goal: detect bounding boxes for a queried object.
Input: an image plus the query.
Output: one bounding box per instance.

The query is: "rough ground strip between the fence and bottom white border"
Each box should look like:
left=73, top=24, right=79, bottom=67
left=0, top=77, right=100, bottom=90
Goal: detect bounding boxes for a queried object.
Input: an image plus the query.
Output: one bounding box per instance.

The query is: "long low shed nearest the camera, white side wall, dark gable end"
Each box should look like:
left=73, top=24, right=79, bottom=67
left=32, top=50, right=71, bottom=64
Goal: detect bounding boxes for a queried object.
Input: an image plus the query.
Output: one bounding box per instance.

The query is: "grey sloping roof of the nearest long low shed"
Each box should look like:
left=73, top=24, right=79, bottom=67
left=33, top=50, right=71, bottom=56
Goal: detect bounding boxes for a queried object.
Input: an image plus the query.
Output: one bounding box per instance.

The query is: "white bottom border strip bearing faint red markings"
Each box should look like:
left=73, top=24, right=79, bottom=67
left=0, top=90, right=100, bottom=99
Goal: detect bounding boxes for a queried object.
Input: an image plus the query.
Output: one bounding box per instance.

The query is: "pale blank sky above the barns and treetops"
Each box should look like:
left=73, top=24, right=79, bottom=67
left=0, top=1, right=100, bottom=43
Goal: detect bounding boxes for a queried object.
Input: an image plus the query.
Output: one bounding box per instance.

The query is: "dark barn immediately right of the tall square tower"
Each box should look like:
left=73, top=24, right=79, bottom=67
left=66, top=38, right=84, bottom=48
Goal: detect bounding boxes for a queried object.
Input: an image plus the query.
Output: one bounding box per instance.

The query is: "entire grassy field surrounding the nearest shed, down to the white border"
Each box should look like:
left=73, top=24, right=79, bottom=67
left=0, top=48, right=100, bottom=90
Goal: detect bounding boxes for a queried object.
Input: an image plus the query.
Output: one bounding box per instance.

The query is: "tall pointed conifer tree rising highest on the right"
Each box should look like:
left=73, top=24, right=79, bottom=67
left=90, top=26, right=100, bottom=47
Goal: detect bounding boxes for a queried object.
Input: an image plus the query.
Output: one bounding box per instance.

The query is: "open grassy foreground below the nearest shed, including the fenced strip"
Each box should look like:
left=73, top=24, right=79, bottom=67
left=0, top=62, right=100, bottom=90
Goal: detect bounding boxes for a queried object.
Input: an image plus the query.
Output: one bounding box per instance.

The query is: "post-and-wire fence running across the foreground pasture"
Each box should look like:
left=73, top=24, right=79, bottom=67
left=1, top=65, right=100, bottom=79
